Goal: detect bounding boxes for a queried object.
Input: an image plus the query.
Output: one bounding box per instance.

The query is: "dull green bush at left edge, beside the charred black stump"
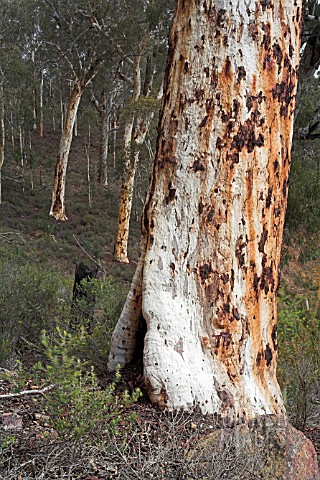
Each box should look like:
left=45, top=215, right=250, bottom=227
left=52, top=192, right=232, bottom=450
left=0, top=249, right=70, bottom=363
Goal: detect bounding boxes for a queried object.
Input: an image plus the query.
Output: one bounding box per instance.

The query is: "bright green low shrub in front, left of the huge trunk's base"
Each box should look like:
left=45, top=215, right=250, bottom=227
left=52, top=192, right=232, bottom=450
left=34, top=327, right=141, bottom=442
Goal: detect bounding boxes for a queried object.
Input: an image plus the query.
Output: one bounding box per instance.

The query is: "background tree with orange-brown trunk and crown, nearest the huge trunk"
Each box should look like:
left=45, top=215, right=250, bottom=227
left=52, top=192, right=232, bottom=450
left=114, top=0, right=173, bottom=263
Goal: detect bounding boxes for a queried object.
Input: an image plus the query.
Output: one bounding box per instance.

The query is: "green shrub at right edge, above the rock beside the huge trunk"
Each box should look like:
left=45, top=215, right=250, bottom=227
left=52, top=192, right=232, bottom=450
left=278, top=291, right=320, bottom=429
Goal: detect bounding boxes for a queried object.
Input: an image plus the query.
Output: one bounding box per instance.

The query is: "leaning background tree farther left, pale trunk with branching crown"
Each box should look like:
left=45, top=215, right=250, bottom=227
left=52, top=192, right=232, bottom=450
left=41, top=0, right=111, bottom=220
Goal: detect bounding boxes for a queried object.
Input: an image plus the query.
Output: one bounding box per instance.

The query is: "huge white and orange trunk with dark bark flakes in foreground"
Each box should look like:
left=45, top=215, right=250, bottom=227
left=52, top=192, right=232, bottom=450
left=109, top=0, right=302, bottom=417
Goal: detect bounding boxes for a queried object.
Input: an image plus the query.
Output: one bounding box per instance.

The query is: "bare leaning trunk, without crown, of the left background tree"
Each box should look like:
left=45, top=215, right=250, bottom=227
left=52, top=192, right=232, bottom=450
left=50, top=81, right=84, bottom=221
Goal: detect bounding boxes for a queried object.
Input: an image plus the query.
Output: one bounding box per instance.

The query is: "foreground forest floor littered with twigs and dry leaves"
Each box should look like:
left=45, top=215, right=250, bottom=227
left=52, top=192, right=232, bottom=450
left=0, top=366, right=320, bottom=480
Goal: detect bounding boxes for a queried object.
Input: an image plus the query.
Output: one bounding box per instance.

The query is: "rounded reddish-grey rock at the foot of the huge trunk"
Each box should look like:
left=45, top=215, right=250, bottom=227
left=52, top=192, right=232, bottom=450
left=190, top=415, right=320, bottom=480
